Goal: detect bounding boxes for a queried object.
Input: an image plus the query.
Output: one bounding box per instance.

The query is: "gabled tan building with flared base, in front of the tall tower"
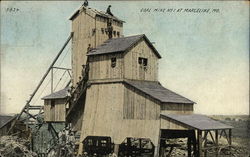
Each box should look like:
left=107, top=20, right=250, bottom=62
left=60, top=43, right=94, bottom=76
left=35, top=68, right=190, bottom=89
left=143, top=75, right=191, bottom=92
left=76, top=35, right=194, bottom=156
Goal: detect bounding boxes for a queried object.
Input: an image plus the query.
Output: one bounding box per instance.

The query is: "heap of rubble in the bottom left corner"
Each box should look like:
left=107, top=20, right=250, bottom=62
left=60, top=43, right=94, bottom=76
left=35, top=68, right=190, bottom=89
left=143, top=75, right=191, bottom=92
left=0, top=136, right=37, bottom=157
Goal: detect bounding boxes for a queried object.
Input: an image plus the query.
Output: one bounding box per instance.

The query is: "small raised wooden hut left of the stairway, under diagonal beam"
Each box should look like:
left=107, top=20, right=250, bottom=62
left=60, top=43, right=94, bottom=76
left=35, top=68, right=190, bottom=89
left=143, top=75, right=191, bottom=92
left=42, top=88, right=68, bottom=122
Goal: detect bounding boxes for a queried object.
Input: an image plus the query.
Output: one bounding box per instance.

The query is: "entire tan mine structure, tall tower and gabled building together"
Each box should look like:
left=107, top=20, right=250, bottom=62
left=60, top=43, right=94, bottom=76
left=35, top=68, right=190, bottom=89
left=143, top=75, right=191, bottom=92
left=67, top=7, right=231, bottom=156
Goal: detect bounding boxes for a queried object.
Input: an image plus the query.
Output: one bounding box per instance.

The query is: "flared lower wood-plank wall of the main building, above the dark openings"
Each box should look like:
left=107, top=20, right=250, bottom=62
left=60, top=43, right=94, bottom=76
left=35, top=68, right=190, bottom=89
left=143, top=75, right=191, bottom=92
left=79, top=83, right=160, bottom=152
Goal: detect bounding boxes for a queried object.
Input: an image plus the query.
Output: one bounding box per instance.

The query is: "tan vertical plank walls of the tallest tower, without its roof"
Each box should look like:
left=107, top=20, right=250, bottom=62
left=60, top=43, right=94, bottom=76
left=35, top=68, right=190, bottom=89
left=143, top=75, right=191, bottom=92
left=72, top=9, right=123, bottom=86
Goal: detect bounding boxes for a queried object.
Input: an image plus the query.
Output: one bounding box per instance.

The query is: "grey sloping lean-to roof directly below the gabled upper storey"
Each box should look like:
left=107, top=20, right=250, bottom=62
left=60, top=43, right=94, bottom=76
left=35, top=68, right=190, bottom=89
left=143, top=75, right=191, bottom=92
left=125, top=80, right=195, bottom=104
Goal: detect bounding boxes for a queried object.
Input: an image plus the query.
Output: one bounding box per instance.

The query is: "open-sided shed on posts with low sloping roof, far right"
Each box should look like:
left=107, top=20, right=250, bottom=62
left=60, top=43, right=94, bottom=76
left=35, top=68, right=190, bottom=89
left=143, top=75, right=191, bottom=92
left=161, top=114, right=233, bottom=156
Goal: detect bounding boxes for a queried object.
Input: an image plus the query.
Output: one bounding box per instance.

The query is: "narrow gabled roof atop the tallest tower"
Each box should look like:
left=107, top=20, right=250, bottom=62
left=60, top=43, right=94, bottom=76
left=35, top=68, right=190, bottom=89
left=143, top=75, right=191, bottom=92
left=69, top=6, right=124, bottom=23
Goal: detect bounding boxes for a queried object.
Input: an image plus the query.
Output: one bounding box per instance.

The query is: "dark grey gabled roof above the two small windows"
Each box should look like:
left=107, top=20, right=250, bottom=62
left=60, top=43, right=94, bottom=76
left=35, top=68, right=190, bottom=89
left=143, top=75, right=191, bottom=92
left=87, top=34, right=161, bottom=58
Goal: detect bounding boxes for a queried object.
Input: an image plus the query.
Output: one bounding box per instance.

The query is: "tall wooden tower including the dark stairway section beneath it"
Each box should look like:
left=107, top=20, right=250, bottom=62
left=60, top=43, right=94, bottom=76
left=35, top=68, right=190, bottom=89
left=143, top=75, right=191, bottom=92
left=67, top=6, right=123, bottom=131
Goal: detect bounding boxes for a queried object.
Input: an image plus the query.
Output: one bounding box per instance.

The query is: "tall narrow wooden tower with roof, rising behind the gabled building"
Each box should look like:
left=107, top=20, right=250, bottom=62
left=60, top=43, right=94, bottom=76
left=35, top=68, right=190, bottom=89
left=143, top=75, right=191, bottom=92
left=70, top=6, right=123, bottom=86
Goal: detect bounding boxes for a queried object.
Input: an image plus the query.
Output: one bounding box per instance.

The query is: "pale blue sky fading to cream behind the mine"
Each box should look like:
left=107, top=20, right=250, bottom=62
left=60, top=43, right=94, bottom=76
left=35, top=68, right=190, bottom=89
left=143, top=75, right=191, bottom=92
left=0, top=1, right=249, bottom=115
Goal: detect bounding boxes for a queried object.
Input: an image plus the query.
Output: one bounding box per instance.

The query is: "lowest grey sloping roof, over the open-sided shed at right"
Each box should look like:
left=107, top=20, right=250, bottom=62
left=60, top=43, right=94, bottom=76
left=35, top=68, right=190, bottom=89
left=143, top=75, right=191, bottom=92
left=161, top=114, right=233, bottom=130
